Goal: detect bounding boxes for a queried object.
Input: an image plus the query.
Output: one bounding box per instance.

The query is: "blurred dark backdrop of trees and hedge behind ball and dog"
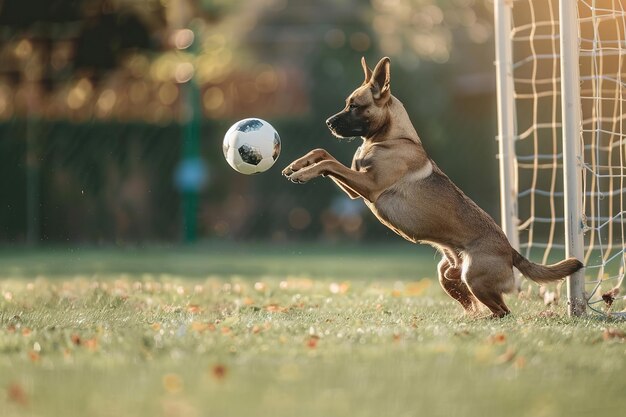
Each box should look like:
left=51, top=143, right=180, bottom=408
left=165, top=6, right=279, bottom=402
left=0, top=0, right=499, bottom=244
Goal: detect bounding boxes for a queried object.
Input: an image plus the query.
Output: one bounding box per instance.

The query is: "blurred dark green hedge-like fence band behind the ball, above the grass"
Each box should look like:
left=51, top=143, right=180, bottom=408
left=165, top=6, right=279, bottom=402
left=0, top=120, right=378, bottom=243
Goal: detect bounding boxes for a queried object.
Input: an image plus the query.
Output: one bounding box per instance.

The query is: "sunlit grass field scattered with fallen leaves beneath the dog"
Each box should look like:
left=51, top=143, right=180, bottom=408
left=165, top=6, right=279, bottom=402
left=0, top=244, right=626, bottom=417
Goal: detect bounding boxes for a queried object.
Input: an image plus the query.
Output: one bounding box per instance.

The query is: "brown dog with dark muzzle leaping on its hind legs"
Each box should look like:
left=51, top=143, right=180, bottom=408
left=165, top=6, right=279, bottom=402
left=283, top=58, right=583, bottom=317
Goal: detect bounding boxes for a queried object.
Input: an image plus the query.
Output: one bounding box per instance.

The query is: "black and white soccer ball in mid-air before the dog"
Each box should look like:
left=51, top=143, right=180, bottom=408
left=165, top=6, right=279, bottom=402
left=222, top=118, right=280, bottom=175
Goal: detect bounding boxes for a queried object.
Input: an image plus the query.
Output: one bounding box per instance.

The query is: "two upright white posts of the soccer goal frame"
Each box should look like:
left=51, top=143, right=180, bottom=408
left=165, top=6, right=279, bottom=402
left=494, top=0, right=587, bottom=316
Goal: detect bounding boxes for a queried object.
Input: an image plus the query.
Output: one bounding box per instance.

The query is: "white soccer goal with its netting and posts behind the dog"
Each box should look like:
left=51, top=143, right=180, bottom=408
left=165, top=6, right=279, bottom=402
left=496, top=0, right=626, bottom=314
